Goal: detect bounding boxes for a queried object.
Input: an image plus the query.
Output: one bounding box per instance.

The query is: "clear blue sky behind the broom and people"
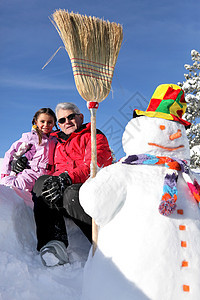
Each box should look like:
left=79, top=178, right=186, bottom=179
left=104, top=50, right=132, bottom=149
left=0, top=0, right=200, bottom=159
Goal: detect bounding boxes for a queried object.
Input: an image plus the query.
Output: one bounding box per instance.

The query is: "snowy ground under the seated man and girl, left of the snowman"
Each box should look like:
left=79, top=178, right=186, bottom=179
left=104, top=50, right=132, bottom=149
left=0, top=159, right=90, bottom=300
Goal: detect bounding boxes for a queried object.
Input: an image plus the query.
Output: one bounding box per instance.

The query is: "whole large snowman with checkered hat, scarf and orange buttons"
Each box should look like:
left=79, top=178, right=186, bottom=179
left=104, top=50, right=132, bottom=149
left=80, top=84, right=200, bottom=300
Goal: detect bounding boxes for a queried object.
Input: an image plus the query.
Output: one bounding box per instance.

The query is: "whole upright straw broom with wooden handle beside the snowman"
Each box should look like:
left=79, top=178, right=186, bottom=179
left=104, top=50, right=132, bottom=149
left=51, top=9, right=123, bottom=255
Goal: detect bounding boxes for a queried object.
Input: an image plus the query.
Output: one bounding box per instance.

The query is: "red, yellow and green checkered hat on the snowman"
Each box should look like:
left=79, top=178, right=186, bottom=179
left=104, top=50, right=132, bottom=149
left=133, top=84, right=191, bottom=127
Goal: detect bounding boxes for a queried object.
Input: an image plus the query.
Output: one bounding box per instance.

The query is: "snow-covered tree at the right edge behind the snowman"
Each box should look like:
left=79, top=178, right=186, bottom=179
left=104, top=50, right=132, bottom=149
left=178, top=50, right=200, bottom=168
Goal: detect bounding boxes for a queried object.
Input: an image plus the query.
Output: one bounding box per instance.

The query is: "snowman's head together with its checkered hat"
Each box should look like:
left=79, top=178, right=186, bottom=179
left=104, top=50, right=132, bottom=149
left=122, top=84, right=191, bottom=162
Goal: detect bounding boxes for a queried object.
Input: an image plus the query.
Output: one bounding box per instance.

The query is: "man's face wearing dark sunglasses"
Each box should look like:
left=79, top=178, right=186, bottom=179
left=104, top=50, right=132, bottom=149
left=57, top=109, right=83, bottom=135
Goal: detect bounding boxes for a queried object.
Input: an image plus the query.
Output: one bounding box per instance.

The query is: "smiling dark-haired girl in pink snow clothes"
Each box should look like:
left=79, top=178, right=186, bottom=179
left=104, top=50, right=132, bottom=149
left=1, top=108, right=57, bottom=192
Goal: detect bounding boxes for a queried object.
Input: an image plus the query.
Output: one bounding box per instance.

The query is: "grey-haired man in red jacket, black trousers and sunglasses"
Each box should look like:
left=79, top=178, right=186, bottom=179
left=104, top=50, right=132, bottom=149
left=33, top=102, right=112, bottom=266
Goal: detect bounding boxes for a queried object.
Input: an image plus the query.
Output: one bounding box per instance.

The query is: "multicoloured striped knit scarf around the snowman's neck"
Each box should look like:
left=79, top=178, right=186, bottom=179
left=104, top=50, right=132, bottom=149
left=122, top=154, right=200, bottom=216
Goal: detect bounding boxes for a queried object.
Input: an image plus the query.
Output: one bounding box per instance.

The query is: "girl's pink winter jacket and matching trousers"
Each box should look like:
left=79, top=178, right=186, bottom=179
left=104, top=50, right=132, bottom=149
left=1, top=129, right=57, bottom=192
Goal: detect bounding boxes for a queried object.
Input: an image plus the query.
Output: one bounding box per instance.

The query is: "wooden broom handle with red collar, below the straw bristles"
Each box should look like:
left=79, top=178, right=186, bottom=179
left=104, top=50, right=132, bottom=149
left=88, top=102, right=99, bottom=256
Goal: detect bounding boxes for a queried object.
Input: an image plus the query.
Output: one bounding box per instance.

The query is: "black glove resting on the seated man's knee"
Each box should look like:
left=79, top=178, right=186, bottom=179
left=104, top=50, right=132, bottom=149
left=41, top=172, right=72, bottom=209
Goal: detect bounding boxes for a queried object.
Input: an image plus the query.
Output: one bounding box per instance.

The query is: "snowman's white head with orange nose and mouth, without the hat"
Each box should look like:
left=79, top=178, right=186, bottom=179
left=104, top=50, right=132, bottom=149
left=122, top=116, right=190, bottom=162
